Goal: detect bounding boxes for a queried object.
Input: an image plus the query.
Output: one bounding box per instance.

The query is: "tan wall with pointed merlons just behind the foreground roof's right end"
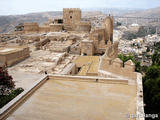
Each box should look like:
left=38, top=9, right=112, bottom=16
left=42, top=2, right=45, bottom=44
left=98, top=42, right=137, bottom=80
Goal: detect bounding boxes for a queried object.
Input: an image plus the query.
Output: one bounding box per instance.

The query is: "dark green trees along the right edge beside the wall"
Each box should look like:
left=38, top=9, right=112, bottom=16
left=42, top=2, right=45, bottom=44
left=143, top=43, right=160, bottom=120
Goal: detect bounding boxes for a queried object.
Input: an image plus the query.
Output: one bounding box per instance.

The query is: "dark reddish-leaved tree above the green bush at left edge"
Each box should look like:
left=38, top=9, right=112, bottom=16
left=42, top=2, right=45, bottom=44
left=0, top=67, right=15, bottom=95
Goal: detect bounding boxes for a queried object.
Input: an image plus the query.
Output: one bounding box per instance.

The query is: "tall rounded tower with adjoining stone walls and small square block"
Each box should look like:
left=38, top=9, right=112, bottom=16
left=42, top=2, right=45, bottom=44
left=81, top=16, right=113, bottom=55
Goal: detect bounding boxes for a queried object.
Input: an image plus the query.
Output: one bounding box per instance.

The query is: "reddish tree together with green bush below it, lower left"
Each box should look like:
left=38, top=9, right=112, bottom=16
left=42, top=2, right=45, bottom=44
left=0, top=67, right=23, bottom=108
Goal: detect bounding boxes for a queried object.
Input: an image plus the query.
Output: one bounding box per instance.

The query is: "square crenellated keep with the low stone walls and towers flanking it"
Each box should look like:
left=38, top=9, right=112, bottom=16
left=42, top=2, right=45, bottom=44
left=18, top=8, right=91, bottom=34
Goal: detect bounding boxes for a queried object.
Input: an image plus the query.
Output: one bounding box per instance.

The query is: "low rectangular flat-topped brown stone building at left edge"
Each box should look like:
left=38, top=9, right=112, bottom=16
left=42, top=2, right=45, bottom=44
left=0, top=46, right=30, bottom=66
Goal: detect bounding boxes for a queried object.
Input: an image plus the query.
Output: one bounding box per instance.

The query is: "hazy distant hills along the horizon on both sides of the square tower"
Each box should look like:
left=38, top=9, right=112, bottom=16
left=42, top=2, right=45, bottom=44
left=0, top=7, right=160, bottom=33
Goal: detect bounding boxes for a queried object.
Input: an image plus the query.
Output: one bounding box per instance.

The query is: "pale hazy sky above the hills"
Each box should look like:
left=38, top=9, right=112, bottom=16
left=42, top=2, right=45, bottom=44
left=0, top=0, right=160, bottom=15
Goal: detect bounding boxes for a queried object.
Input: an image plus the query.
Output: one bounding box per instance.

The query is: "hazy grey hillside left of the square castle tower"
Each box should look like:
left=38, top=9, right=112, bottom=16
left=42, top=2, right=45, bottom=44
left=0, top=12, right=62, bottom=33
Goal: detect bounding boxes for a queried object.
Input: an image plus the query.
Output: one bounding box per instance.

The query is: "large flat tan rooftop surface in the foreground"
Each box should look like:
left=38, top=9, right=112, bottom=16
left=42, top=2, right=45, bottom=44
left=7, top=77, right=136, bottom=120
